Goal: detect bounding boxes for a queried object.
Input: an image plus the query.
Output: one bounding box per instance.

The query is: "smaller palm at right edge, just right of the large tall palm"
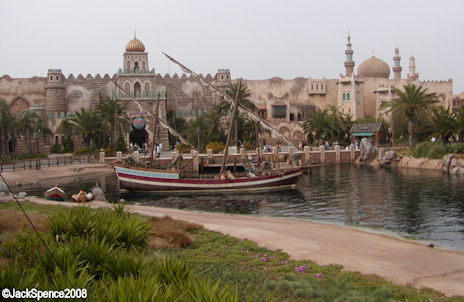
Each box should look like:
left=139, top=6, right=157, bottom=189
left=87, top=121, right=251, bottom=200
left=430, top=106, right=457, bottom=143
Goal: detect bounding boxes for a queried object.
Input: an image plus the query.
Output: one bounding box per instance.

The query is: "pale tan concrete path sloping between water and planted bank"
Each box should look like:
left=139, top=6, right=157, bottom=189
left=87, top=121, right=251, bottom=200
left=22, top=197, right=464, bottom=296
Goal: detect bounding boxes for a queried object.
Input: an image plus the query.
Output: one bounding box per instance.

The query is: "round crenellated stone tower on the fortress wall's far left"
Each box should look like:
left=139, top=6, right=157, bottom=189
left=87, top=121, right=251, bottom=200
left=45, top=69, right=67, bottom=114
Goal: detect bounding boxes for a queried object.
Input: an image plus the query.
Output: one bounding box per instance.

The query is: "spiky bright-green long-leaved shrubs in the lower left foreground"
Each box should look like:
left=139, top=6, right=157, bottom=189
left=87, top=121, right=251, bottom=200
left=0, top=205, right=239, bottom=302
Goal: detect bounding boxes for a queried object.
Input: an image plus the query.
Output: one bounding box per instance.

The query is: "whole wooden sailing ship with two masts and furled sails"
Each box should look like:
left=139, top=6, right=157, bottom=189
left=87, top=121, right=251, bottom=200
left=113, top=54, right=302, bottom=193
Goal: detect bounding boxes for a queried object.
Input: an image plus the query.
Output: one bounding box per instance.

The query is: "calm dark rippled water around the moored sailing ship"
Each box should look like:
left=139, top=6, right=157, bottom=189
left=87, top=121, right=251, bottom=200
left=15, top=165, right=464, bottom=250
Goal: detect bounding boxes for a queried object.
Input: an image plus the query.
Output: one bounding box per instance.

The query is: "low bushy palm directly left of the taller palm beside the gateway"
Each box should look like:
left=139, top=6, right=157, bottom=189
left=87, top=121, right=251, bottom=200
left=59, top=108, right=100, bottom=149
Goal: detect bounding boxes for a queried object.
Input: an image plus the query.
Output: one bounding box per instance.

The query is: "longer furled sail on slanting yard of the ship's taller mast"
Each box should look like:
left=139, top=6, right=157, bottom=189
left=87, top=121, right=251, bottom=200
left=163, top=52, right=298, bottom=148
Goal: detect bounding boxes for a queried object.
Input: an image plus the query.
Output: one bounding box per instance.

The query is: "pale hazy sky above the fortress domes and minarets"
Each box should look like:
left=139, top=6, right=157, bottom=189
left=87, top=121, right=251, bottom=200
left=0, top=0, right=464, bottom=93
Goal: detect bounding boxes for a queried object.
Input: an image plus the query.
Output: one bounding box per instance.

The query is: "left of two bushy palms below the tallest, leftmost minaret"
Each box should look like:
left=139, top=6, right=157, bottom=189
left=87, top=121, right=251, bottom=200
left=303, top=108, right=334, bottom=143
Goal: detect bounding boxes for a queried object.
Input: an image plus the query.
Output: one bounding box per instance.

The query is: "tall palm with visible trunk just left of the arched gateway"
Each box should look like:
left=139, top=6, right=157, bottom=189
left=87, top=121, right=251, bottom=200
left=96, top=98, right=130, bottom=150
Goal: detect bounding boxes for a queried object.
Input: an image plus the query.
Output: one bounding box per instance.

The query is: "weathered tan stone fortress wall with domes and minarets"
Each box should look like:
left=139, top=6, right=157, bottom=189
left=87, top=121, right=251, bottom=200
left=0, top=37, right=457, bottom=153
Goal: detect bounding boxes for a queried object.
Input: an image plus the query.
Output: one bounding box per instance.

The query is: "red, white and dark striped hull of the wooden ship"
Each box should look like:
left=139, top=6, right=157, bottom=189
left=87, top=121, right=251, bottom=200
left=115, top=167, right=302, bottom=193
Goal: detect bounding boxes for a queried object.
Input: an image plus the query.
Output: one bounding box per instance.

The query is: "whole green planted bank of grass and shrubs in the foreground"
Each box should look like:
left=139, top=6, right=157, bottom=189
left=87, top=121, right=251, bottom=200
left=0, top=202, right=464, bottom=302
